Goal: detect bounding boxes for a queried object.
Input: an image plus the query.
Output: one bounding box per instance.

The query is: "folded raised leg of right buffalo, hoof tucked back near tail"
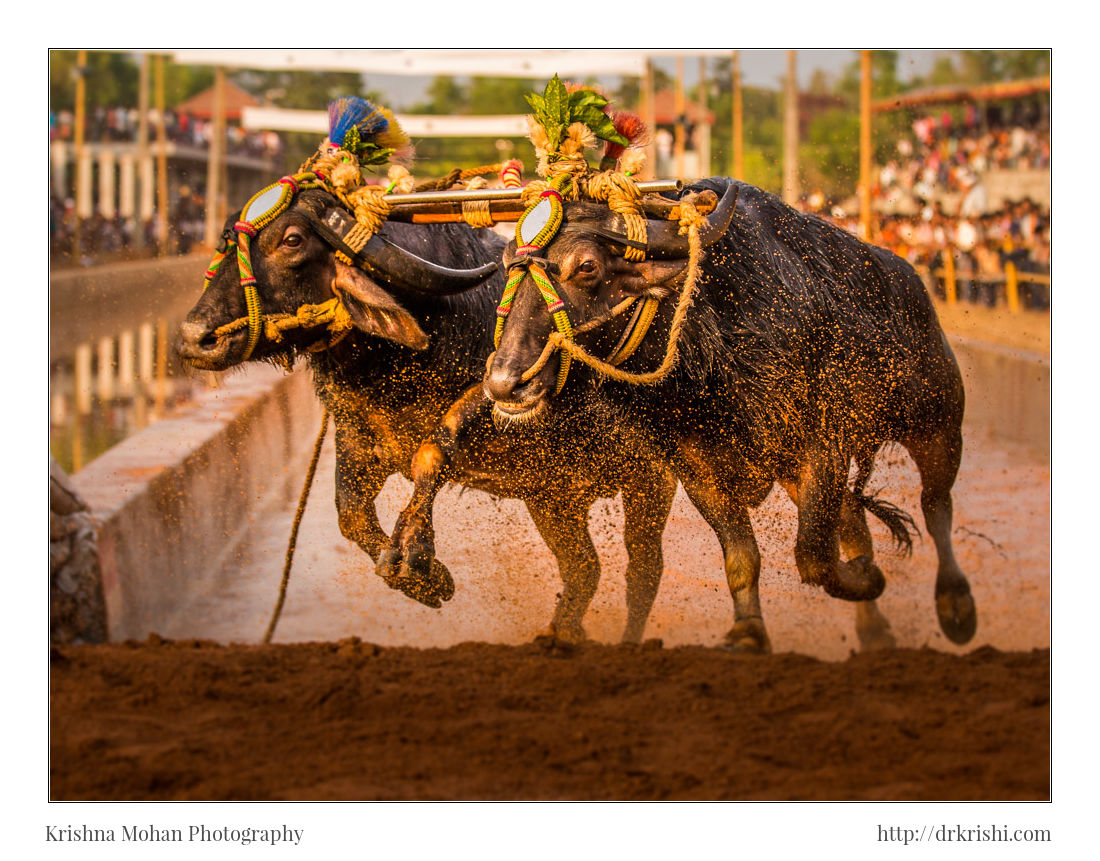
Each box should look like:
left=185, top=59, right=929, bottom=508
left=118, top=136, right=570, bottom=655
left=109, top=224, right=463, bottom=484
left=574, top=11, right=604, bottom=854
left=794, top=445, right=886, bottom=600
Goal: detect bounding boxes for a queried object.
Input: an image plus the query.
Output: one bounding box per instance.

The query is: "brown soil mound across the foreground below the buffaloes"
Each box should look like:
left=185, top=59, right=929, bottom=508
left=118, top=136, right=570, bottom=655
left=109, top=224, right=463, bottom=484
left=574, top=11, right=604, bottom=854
left=50, top=636, right=1049, bottom=801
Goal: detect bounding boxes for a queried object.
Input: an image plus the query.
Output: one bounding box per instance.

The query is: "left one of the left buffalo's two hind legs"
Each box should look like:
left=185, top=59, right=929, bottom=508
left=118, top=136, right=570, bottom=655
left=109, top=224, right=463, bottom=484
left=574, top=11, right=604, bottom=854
left=527, top=497, right=600, bottom=642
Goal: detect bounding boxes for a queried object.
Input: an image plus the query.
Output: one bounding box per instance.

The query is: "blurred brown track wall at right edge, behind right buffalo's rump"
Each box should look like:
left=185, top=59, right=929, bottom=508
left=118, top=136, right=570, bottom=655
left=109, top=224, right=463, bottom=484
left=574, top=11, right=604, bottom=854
left=948, top=335, right=1051, bottom=462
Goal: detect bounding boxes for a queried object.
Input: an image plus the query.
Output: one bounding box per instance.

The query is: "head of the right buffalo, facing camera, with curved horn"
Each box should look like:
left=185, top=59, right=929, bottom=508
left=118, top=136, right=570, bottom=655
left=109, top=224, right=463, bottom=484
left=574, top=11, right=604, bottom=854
left=484, top=184, right=737, bottom=420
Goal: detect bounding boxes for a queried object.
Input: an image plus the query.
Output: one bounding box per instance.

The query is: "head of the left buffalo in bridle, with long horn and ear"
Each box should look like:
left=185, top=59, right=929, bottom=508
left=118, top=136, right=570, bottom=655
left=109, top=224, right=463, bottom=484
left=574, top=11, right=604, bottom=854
left=177, top=189, right=497, bottom=371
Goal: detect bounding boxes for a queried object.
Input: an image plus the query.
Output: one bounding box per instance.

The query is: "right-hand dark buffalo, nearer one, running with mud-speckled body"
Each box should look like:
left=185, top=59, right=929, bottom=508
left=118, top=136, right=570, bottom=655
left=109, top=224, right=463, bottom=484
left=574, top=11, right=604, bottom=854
left=484, top=178, right=976, bottom=643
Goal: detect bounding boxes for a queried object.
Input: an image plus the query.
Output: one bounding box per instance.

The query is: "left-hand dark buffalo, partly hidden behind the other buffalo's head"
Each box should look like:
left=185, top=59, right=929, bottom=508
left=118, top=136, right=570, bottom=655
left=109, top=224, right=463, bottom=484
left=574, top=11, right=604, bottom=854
left=178, top=189, right=675, bottom=641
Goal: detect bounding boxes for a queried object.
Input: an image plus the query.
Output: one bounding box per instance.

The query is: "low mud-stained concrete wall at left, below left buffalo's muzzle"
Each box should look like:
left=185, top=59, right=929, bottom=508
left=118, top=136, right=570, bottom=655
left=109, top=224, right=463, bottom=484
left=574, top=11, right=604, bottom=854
left=73, top=365, right=322, bottom=640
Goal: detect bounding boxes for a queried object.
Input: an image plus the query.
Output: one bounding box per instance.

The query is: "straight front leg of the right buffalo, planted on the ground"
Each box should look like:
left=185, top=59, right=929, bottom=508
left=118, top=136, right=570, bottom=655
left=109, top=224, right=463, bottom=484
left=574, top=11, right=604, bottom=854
left=677, top=443, right=771, bottom=654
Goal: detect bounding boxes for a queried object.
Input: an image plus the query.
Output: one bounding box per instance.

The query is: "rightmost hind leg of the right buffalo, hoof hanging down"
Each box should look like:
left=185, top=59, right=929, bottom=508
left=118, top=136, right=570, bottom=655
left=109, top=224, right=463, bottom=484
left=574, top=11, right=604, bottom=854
left=903, top=428, right=978, bottom=644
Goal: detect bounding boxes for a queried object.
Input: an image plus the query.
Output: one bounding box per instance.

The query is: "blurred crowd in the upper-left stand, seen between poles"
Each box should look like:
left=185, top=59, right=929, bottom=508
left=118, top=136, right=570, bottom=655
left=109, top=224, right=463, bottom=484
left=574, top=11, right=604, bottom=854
left=50, top=108, right=283, bottom=158
